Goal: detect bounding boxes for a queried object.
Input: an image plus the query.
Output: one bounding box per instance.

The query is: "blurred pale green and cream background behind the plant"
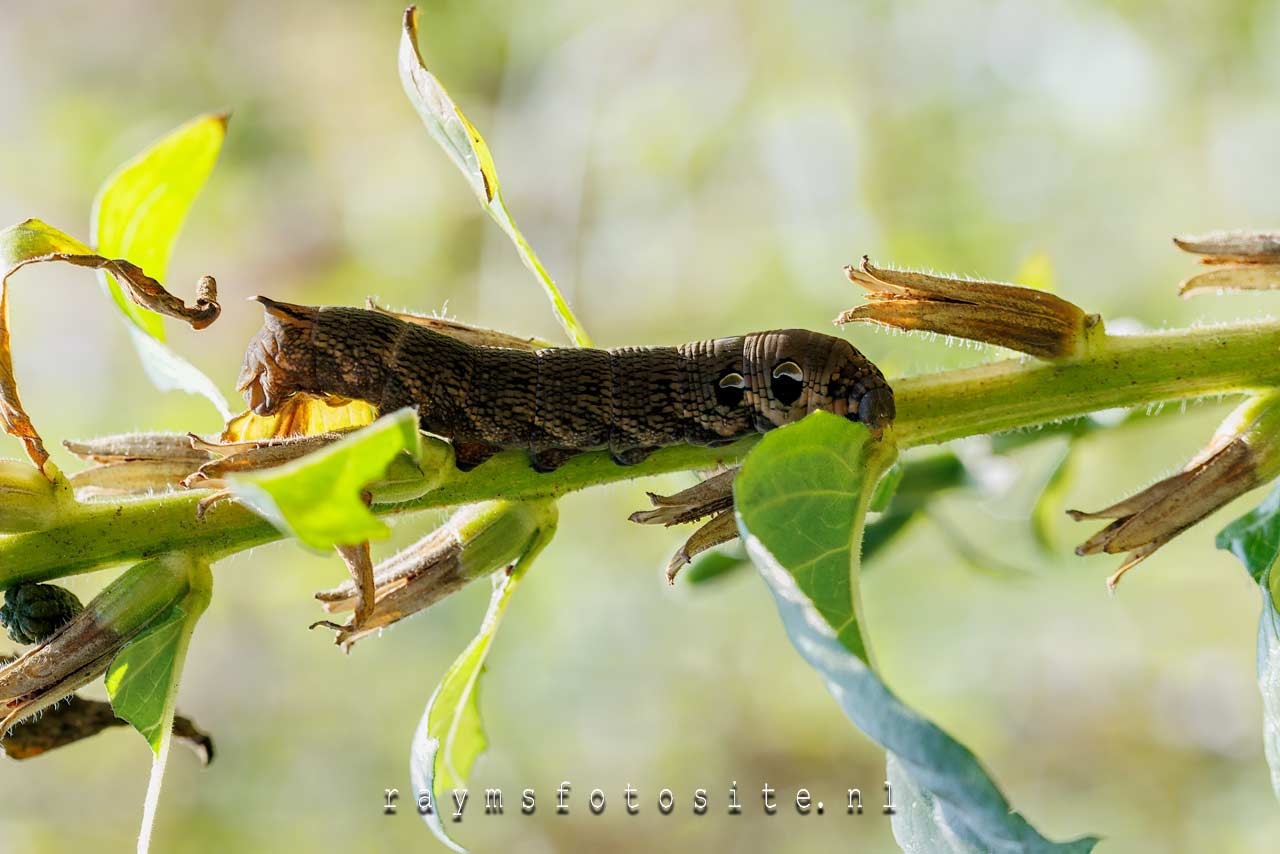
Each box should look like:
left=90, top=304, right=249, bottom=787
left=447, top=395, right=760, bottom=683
left=0, top=0, right=1280, bottom=853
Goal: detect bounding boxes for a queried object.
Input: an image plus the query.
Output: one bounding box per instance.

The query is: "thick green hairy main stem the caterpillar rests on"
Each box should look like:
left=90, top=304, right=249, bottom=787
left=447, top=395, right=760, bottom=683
left=0, top=321, right=1280, bottom=588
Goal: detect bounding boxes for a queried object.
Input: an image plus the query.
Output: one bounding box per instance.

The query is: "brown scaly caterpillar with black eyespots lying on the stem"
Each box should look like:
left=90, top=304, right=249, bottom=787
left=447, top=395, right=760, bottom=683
left=239, top=297, right=893, bottom=471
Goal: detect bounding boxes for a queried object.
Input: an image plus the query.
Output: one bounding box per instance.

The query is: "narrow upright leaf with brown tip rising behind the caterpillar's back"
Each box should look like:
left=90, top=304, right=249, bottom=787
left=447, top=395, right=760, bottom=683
left=399, top=6, right=591, bottom=347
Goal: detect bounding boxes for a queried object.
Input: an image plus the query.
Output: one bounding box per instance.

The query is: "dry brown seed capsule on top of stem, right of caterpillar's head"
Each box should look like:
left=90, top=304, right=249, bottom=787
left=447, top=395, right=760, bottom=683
left=836, top=256, right=1100, bottom=360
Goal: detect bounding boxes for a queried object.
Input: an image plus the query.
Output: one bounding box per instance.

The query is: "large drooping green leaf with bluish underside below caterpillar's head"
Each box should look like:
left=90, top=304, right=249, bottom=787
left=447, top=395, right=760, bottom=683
left=735, top=412, right=1094, bottom=854
